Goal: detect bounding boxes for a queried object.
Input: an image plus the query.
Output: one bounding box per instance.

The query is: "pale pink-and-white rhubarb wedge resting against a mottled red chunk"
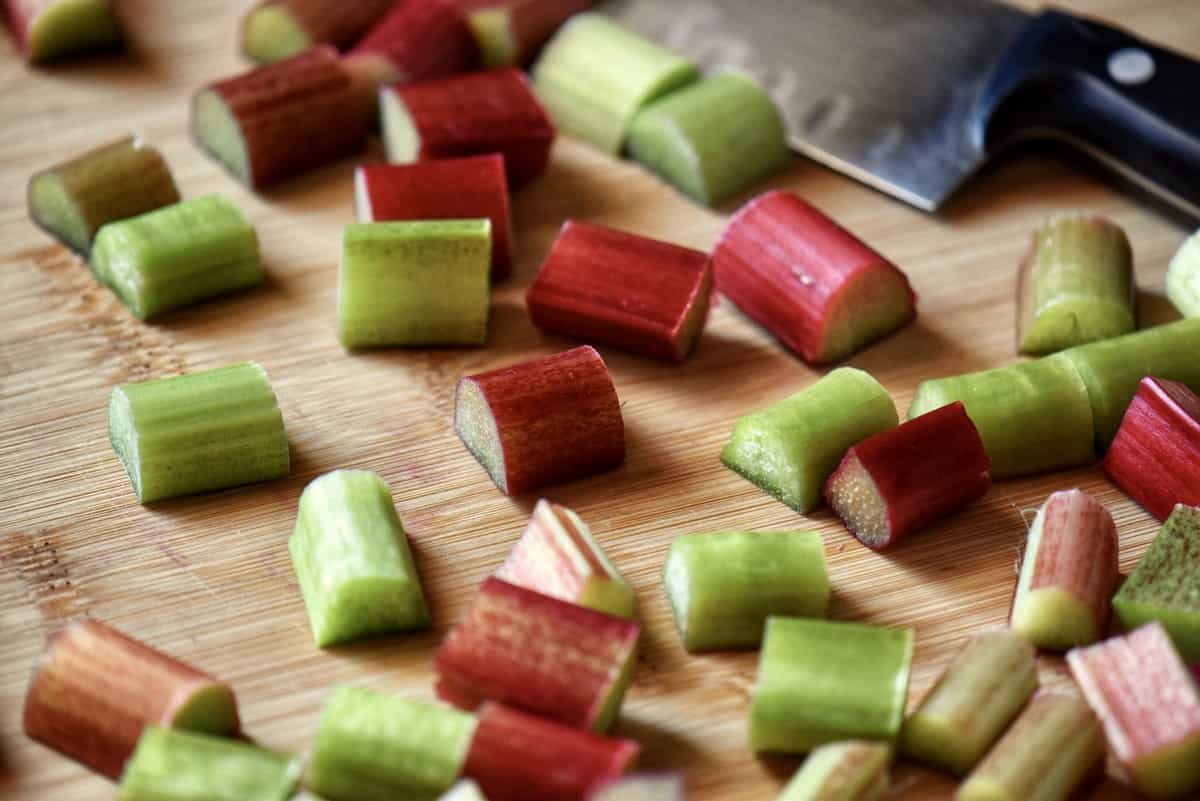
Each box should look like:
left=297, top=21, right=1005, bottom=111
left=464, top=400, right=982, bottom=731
left=496, top=499, right=636, bottom=618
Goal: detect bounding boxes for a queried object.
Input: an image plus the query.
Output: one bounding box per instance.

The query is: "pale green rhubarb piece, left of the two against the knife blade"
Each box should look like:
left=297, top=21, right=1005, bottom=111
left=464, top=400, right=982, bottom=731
left=533, top=13, right=698, bottom=153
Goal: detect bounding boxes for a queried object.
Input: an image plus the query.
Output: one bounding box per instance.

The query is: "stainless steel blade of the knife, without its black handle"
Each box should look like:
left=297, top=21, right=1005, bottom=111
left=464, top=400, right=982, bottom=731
left=599, top=0, right=1028, bottom=211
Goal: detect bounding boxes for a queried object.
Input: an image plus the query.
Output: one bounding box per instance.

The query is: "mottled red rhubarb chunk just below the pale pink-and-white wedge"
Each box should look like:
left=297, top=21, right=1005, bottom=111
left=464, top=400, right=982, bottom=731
left=434, top=577, right=641, bottom=731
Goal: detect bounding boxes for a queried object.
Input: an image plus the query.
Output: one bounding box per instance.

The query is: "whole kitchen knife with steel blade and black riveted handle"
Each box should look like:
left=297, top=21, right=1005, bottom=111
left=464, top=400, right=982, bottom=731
left=601, top=0, right=1200, bottom=218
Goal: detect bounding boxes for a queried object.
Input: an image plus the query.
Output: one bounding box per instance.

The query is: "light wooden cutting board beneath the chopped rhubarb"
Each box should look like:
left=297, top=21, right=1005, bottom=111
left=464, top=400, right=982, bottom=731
left=0, top=0, right=1200, bottom=801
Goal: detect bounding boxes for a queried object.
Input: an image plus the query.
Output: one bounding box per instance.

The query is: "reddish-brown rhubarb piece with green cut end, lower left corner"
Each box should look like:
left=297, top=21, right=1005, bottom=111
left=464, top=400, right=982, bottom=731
left=24, top=620, right=239, bottom=779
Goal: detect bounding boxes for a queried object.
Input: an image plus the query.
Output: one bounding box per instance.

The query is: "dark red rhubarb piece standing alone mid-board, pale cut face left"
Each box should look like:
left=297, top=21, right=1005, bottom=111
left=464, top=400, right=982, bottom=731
left=454, top=345, right=625, bottom=495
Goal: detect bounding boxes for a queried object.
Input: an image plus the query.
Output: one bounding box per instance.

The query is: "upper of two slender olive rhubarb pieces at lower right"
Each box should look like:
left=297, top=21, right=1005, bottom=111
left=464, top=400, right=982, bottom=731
left=900, top=628, right=1038, bottom=776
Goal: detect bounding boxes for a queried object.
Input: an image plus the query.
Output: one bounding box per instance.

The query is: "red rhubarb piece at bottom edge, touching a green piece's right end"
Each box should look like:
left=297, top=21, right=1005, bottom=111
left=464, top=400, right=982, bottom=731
left=463, top=700, right=638, bottom=801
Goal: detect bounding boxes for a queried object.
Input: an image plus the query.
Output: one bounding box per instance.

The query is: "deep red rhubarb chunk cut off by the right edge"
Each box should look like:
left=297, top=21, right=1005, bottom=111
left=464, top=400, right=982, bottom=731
left=1104, top=377, right=1200, bottom=520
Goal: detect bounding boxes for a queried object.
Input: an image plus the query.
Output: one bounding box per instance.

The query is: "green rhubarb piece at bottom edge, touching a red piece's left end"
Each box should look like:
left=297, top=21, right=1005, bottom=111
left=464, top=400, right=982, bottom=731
left=307, top=686, right=475, bottom=801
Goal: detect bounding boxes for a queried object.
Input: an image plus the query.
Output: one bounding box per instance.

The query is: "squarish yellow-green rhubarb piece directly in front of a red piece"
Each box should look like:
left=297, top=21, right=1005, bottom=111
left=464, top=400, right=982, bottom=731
left=337, top=219, right=492, bottom=348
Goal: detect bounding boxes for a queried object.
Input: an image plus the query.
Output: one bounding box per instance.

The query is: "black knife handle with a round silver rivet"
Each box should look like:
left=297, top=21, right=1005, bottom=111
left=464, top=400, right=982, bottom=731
left=976, top=11, right=1200, bottom=217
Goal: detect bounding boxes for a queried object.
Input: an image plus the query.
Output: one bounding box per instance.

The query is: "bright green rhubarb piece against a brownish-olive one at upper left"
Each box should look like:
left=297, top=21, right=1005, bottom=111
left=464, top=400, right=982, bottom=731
left=91, top=194, right=266, bottom=320
